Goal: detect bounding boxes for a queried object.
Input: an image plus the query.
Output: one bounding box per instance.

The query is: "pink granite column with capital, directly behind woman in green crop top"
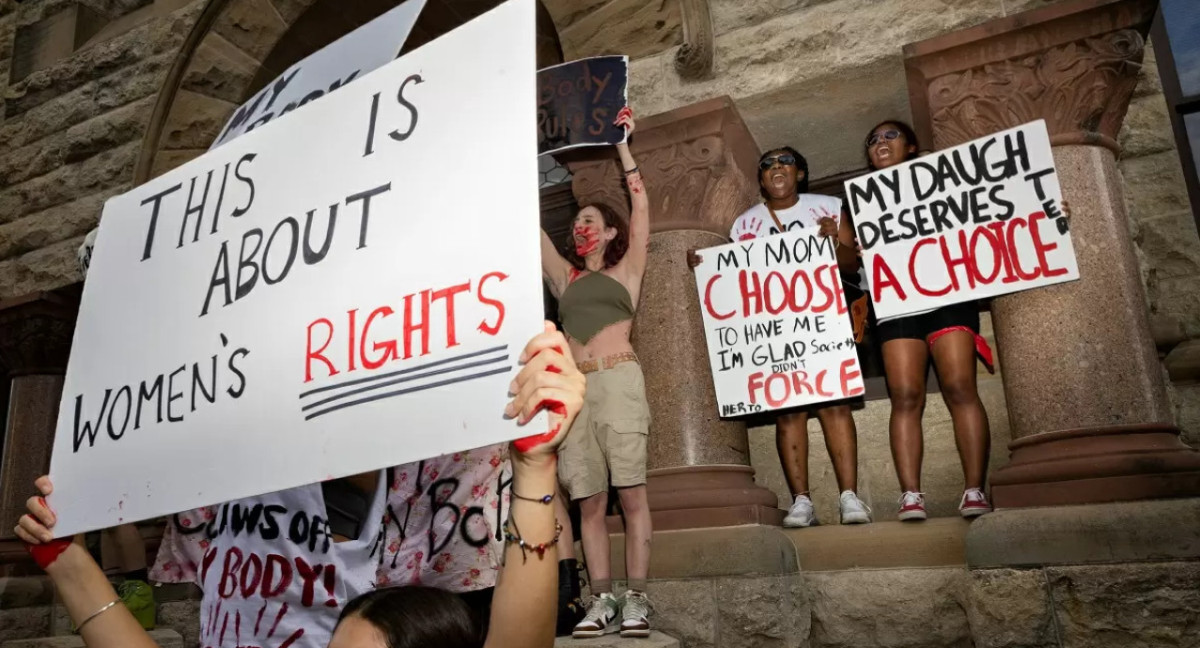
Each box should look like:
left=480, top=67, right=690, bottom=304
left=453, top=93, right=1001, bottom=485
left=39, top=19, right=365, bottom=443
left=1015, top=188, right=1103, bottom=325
left=569, top=97, right=782, bottom=530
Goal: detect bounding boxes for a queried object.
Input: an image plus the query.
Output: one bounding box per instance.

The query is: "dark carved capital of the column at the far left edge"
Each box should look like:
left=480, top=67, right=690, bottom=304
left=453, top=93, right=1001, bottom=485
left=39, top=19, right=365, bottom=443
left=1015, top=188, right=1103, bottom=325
left=0, top=293, right=78, bottom=377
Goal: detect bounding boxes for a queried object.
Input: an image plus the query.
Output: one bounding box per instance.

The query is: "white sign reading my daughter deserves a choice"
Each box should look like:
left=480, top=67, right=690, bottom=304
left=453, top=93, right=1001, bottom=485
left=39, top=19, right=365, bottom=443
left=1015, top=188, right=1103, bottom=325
left=846, top=121, right=1079, bottom=319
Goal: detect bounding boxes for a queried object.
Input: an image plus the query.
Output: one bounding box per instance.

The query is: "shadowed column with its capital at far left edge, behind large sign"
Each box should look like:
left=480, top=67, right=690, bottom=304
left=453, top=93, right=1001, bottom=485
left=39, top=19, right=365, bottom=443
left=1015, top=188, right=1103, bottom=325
left=0, top=293, right=76, bottom=539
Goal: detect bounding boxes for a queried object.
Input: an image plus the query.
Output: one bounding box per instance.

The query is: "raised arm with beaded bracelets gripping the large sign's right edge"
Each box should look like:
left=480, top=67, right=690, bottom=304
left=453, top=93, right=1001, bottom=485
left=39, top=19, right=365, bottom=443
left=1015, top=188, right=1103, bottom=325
left=484, top=322, right=586, bottom=648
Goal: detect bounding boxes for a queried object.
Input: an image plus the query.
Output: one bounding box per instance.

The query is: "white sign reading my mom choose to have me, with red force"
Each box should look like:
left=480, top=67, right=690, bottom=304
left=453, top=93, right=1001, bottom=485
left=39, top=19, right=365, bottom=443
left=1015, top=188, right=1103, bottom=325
left=696, top=230, right=864, bottom=416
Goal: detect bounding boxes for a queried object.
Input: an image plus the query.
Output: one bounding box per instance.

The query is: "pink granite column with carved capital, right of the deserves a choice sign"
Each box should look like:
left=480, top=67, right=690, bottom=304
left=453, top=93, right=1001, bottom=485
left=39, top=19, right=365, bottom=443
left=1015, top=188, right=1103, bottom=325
left=905, top=0, right=1200, bottom=508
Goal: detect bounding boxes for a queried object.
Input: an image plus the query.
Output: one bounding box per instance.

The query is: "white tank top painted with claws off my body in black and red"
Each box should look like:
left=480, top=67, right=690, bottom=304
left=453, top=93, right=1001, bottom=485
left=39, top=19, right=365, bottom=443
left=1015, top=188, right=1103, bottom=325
left=197, top=474, right=386, bottom=648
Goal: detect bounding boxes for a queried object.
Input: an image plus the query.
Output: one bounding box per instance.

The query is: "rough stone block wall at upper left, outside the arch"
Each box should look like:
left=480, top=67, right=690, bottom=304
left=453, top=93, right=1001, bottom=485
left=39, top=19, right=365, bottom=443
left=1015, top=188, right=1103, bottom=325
left=0, top=0, right=205, bottom=298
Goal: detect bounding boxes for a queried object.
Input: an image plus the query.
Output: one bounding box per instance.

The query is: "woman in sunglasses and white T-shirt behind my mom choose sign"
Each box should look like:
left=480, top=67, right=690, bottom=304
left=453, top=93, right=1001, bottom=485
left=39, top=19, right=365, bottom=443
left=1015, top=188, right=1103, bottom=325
left=730, top=146, right=871, bottom=527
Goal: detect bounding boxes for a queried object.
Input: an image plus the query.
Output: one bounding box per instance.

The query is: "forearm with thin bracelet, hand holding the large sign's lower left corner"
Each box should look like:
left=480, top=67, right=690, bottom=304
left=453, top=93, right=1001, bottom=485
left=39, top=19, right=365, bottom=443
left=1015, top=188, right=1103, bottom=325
left=16, top=476, right=158, bottom=648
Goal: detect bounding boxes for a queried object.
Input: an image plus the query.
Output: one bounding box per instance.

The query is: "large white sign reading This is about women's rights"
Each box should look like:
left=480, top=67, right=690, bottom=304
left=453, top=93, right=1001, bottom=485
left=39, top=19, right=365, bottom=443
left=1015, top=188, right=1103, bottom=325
left=50, top=0, right=547, bottom=535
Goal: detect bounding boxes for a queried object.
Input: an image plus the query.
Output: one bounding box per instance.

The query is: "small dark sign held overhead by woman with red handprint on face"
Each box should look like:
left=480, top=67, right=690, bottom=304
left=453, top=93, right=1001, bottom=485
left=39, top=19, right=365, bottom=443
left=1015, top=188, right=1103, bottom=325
left=538, top=56, right=629, bottom=155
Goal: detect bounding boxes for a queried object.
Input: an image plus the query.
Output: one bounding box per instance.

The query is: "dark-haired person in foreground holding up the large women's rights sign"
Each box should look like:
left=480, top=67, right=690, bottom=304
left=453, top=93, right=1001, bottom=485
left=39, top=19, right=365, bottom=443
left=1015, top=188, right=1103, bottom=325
left=16, top=323, right=586, bottom=648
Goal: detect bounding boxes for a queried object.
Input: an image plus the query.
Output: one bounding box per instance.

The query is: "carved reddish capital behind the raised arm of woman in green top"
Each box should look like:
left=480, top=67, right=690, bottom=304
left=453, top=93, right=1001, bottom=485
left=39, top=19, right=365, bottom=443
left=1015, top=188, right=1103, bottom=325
left=566, top=97, right=758, bottom=236
